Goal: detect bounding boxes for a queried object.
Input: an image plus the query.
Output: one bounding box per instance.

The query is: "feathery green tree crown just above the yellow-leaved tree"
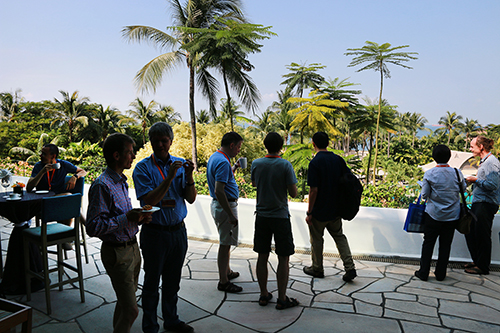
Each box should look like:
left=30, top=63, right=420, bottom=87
left=281, top=62, right=326, bottom=98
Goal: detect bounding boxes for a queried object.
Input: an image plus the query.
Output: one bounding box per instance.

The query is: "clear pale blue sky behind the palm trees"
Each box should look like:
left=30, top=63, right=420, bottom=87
left=0, top=0, right=500, bottom=125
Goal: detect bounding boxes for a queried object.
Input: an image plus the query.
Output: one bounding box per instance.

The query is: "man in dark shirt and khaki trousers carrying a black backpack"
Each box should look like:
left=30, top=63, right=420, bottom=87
left=304, top=132, right=356, bottom=282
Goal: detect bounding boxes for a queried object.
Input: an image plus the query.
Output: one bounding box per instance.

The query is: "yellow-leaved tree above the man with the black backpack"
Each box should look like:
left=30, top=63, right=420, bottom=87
left=288, top=90, right=349, bottom=144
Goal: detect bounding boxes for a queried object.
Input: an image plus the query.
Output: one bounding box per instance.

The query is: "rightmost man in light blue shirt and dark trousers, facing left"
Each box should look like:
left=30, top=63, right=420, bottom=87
left=465, top=136, right=500, bottom=274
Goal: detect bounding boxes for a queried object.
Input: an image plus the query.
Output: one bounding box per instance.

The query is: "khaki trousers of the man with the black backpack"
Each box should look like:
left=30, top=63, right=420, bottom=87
left=309, top=217, right=355, bottom=272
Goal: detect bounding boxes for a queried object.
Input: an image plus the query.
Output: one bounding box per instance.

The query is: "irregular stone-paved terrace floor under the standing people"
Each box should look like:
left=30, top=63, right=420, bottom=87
left=0, top=221, right=500, bottom=333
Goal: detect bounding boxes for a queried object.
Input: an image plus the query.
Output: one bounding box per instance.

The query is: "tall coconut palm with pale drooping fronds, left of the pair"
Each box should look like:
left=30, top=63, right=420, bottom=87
left=122, top=0, right=244, bottom=170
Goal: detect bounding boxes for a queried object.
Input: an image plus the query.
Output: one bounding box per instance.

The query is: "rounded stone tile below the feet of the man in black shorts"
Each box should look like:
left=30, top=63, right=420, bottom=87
left=217, top=302, right=303, bottom=332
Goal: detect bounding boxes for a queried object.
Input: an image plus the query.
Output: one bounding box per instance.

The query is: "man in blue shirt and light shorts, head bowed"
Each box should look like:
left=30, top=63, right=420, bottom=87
left=207, top=132, right=243, bottom=293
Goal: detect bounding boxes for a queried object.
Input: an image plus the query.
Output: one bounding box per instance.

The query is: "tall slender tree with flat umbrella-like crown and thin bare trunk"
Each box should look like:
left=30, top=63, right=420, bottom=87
left=344, top=41, right=418, bottom=184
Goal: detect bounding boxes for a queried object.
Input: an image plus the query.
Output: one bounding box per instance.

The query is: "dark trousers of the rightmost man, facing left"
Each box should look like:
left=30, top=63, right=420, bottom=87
left=465, top=202, right=498, bottom=273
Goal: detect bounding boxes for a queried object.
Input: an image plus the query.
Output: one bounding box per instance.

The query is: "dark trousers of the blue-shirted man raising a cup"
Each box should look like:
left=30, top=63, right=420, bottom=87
left=141, top=225, right=188, bottom=333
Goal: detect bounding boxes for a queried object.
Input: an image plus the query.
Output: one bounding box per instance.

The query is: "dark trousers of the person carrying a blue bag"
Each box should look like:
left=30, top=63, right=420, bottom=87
left=420, top=213, right=456, bottom=280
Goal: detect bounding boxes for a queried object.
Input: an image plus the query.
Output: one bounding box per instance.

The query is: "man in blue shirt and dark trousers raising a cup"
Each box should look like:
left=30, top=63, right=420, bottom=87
left=133, top=122, right=196, bottom=333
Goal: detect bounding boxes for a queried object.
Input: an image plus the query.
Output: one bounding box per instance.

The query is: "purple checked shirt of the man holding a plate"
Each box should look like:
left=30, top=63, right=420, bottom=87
left=85, top=167, right=139, bottom=242
